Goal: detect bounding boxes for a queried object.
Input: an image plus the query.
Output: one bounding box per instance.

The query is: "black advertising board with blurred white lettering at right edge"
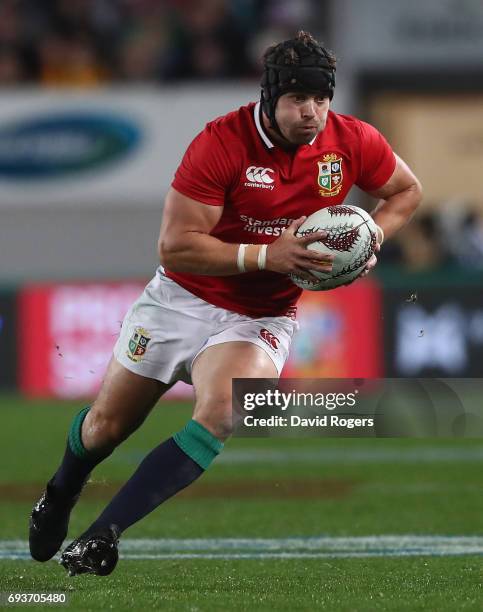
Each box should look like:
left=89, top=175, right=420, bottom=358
left=384, top=287, right=483, bottom=377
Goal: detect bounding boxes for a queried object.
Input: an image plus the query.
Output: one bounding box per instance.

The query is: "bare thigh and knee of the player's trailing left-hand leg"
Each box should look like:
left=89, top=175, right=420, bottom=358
left=82, top=357, right=171, bottom=447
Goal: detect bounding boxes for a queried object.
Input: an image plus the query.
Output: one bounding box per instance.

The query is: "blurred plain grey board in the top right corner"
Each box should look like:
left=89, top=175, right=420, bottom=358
left=334, top=0, right=483, bottom=70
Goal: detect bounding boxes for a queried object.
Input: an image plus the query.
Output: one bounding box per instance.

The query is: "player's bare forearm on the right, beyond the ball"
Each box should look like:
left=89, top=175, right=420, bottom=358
left=372, top=183, right=422, bottom=240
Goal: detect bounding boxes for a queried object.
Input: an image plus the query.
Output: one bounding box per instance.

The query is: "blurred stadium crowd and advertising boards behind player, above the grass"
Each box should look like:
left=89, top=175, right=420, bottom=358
left=0, top=0, right=483, bottom=398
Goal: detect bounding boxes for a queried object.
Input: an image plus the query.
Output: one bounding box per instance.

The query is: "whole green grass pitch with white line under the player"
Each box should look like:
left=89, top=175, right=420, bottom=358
left=0, top=396, right=483, bottom=611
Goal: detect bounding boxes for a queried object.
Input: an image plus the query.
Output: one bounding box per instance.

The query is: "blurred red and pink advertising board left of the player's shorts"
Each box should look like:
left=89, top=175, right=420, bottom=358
left=18, top=282, right=144, bottom=398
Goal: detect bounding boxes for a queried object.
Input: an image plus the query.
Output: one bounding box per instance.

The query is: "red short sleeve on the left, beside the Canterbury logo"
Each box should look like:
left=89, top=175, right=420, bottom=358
left=172, top=124, right=233, bottom=206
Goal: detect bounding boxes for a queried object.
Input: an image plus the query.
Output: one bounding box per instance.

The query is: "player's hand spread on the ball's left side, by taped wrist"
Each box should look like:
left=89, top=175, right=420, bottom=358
left=266, top=217, right=334, bottom=281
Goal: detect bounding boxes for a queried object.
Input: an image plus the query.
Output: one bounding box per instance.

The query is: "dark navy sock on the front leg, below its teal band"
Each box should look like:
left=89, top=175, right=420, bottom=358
left=87, top=438, right=204, bottom=533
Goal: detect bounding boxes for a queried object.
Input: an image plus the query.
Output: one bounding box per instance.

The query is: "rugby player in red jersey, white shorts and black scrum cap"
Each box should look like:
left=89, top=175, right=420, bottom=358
left=30, top=32, right=421, bottom=575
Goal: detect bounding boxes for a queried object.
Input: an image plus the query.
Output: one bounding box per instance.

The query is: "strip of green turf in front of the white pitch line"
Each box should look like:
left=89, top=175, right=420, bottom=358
left=1, top=556, right=483, bottom=612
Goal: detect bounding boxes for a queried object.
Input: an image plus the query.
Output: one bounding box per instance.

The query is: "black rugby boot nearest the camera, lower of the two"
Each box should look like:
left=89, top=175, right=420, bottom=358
left=60, top=525, right=120, bottom=576
